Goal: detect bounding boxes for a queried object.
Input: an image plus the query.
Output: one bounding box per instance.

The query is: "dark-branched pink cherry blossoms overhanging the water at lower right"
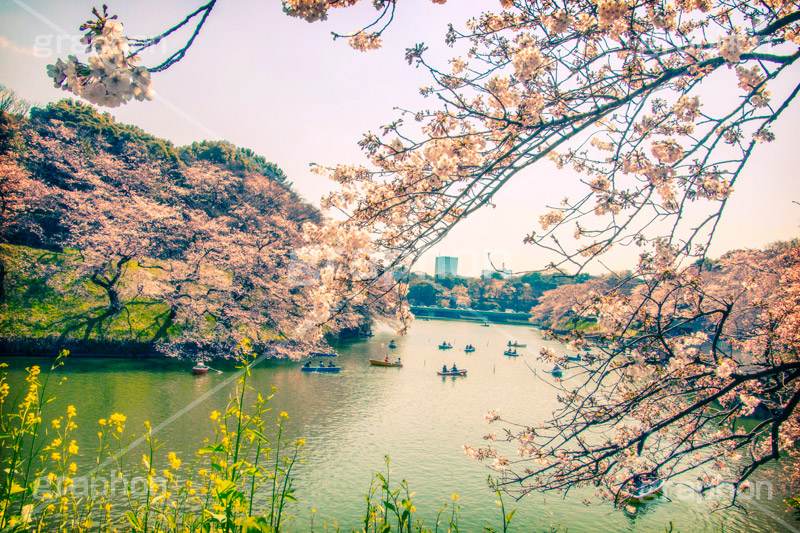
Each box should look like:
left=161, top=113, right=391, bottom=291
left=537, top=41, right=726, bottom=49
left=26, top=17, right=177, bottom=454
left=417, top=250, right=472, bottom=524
left=465, top=244, right=800, bottom=502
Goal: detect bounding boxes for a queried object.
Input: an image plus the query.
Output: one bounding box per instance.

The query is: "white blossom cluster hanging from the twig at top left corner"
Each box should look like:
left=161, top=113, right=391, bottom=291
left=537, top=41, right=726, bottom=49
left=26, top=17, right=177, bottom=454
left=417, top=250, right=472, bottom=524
left=47, top=20, right=153, bottom=107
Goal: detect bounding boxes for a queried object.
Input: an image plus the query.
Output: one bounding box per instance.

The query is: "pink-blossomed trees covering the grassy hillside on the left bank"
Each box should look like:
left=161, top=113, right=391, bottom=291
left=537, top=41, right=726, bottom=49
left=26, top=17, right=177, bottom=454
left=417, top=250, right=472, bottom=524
left=0, top=102, right=346, bottom=357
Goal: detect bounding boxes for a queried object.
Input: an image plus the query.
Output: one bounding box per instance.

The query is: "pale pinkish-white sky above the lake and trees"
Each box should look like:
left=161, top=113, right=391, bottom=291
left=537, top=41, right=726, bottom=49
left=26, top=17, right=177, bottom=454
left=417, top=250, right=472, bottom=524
left=0, top=0, right=800, bottom=275
